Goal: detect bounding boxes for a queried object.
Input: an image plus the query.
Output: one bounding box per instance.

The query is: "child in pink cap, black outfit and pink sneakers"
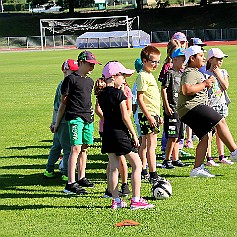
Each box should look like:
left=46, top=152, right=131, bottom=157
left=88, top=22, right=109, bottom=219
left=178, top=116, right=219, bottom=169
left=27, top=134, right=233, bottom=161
left=98, top=62, right=153, bottom=210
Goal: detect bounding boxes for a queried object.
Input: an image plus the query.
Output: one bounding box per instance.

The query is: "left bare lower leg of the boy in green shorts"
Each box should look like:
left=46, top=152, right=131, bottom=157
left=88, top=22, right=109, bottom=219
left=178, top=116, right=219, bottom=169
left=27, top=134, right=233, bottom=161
left=68, top=145, right=81, bottom=184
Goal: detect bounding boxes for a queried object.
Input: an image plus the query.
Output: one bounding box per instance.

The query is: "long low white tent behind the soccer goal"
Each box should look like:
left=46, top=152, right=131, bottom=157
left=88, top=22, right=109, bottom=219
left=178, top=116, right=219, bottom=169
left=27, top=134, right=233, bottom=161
left=76, top=30, right=150, bottom=49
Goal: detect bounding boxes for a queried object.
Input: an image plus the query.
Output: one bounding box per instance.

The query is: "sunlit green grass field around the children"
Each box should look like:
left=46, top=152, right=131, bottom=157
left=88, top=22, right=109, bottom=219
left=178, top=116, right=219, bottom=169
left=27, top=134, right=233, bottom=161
left=0, top=46, right=237, bottom=237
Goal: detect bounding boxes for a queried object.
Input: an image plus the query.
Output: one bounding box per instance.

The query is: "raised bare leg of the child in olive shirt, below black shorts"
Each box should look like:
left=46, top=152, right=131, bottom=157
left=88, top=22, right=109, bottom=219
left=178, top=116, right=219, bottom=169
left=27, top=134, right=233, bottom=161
left=216, top=118, right=237, bottom=152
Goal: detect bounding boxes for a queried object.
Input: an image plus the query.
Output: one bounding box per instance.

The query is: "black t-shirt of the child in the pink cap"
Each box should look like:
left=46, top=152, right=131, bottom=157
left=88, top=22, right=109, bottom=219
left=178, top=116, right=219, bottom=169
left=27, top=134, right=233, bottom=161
left=98, top=86, right=127, bottom=131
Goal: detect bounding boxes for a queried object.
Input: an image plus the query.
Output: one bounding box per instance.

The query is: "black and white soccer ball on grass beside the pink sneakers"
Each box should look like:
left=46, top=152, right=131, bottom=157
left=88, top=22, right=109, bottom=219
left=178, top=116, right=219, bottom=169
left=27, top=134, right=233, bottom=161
left=151, top=180, right=172, bottom=200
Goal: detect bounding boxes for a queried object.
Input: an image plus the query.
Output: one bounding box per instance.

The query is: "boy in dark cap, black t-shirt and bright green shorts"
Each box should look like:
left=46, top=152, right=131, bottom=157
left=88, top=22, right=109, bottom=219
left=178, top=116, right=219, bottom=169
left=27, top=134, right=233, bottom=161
left=55, top=51, right=100, bottom=194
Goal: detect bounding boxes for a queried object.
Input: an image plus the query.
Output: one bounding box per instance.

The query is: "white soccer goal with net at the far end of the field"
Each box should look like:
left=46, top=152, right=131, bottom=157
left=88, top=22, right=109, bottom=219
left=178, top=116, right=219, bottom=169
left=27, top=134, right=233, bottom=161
left=40, top=16, right=139, bottom=50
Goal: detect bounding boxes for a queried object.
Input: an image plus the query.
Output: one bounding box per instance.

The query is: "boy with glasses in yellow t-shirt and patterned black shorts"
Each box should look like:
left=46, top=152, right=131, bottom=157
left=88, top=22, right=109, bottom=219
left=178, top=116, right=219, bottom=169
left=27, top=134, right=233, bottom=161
left=136, top=45, right=163, bottom=184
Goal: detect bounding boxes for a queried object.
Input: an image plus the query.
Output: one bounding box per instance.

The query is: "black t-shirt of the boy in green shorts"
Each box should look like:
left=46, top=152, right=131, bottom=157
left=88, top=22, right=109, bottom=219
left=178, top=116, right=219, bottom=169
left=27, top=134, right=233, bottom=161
left=61, top=73, right=94, bottom=123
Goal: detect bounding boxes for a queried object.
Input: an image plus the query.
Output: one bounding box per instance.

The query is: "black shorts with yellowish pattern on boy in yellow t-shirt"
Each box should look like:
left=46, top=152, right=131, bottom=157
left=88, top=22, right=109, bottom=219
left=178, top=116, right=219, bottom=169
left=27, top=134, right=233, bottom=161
left=138, top=113, right=160, bottom=135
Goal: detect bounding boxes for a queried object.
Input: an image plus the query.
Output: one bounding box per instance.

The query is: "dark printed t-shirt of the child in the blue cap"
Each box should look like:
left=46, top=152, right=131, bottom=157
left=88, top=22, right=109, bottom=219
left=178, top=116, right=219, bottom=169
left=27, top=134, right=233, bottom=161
left=162, top=68, right=182, bottom=111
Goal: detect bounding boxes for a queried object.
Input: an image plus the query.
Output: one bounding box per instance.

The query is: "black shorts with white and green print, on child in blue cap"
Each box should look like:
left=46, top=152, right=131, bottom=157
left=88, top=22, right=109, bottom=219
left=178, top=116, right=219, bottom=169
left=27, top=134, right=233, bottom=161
left=164, top=113, right=184, bottom=139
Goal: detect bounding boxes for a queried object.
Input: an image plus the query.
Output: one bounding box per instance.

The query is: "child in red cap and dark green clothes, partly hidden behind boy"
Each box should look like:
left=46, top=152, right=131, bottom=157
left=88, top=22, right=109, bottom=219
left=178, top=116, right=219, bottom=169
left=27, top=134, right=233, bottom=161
left=44, top=59, right=78, bottom=181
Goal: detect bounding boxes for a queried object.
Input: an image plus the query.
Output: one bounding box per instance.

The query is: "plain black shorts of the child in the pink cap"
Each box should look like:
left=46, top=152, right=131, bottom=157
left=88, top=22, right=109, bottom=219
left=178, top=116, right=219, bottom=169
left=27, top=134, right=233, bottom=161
left=101, top=128, right=136, bottom=156
